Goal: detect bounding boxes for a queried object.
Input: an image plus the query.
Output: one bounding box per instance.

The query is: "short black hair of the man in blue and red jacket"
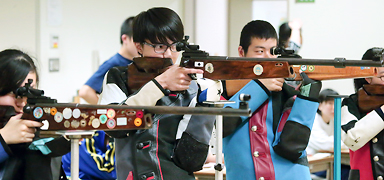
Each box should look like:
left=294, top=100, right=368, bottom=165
left=240, top=20, right=278, bottom=54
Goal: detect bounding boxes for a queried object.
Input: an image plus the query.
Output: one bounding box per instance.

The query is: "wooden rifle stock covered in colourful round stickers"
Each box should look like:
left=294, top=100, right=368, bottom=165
left=0, top=103, right=152, bottom=132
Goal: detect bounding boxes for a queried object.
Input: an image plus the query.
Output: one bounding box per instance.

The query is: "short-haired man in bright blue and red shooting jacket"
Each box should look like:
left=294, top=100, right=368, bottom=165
left=223, top=20, right=321, bottom=180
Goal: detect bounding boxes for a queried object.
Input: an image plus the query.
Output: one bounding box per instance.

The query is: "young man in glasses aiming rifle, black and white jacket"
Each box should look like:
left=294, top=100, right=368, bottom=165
left=99, top=8, right=221, bottom=180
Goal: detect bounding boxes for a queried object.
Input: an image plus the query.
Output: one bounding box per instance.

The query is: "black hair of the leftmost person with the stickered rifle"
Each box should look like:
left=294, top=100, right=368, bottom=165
left=0, top=49, right=39, bottom=96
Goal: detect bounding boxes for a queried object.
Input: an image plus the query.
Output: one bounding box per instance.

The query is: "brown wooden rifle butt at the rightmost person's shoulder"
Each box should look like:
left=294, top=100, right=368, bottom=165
left=357, top=84, right=384, bottom=113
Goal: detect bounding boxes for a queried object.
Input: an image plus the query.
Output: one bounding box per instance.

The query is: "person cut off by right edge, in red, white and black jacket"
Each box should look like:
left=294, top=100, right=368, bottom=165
left=341, top=48, right=384, bottom=180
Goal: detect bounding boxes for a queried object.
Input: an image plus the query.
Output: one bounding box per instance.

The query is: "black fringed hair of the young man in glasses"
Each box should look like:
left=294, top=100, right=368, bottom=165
left=133, top=7, right=184, bottom=44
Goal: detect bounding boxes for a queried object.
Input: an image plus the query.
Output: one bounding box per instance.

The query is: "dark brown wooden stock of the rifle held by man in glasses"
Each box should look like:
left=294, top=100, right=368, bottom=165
left=127, top=56, right=294, bottom=93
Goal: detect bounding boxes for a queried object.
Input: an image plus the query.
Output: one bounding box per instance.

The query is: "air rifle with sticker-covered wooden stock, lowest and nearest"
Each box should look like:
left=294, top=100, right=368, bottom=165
left=0, top=79, right=251, bottom=131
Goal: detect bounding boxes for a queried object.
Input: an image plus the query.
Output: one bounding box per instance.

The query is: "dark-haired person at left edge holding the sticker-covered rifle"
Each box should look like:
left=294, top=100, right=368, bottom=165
left=0, top=49, right=70, bottom=180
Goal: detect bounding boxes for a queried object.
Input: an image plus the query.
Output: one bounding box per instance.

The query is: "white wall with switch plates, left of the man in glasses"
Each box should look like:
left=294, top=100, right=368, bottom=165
left=38, top=0, right=183, bottom=102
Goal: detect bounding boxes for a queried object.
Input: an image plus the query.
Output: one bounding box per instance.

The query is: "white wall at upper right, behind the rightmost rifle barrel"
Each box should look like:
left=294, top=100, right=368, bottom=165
left=289, top=0, right=384, bottom=95
